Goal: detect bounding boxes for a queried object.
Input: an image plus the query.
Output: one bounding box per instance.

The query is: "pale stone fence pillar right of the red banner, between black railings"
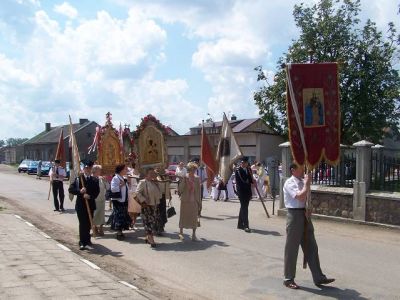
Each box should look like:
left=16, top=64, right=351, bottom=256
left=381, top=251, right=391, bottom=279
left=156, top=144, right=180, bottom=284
left=353, top=140, right=374, bottom=221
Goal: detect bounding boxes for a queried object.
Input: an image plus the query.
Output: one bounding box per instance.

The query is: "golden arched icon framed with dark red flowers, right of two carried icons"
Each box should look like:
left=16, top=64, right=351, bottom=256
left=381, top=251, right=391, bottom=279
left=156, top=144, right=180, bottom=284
left=133, top=115, right=169, bottom=172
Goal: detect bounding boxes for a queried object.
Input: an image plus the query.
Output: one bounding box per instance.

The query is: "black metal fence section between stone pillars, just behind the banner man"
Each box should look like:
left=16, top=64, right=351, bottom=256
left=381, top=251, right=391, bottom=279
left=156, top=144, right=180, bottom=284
left=311, top=147, right=356, bottom=187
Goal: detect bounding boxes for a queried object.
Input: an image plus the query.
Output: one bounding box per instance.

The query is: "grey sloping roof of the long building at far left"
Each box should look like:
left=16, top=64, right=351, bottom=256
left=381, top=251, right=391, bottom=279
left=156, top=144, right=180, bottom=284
left=23, top=121, right=96, bottom=145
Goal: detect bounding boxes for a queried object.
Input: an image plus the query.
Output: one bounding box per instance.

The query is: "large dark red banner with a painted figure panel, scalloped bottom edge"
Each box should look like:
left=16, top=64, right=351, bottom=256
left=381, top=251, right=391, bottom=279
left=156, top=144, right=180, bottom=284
left=287, top=63, right=340, bottom=169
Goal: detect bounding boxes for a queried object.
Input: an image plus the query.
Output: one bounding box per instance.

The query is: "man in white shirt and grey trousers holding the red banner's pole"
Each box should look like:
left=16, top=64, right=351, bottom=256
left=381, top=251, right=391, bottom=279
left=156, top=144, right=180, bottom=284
left=283, top=163, right=335, bottom=289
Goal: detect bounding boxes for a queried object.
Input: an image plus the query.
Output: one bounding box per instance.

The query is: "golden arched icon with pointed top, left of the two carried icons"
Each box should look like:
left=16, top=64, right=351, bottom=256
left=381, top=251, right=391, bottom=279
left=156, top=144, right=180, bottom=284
left=96, top=113, right=124, bottom=176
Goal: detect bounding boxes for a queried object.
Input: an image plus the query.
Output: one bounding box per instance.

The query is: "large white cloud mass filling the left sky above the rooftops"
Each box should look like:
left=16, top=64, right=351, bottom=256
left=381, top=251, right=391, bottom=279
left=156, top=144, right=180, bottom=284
left=0, top=5, right=198, bottom=139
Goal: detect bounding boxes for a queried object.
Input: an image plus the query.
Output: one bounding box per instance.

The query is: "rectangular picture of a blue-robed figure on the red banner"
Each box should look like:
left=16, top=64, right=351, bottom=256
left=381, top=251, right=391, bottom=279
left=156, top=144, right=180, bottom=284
left=303, top=88, right=325, bottom=127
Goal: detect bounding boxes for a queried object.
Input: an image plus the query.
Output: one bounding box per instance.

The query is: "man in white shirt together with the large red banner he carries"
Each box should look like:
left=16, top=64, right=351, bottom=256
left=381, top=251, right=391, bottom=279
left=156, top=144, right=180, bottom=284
left=283, top=63, right=340, bottom=289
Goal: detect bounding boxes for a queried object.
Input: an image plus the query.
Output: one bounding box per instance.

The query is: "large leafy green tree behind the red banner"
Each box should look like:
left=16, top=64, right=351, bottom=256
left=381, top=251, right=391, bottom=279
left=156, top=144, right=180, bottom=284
left=254, top=0, right=400, bottom=144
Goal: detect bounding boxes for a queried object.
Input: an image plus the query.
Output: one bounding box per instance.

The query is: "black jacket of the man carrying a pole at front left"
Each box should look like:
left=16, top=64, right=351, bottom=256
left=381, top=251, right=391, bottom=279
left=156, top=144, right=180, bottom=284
left=68, top=175, right=100, bottom=212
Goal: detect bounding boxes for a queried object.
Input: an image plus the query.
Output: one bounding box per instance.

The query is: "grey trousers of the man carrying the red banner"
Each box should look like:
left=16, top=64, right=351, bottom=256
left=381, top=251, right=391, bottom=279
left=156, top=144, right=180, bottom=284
left=284, top=210, right=326, bottom=283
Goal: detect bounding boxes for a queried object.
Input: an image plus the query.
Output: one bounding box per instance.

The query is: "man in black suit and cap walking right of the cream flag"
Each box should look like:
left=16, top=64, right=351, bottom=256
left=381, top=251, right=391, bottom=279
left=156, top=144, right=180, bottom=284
left=235, top=157, right=253, bottom=232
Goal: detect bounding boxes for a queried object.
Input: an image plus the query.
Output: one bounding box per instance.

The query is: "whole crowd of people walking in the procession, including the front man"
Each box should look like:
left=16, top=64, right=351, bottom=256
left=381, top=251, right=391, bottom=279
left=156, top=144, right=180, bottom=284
left=49, top=157, right=334, bottom=289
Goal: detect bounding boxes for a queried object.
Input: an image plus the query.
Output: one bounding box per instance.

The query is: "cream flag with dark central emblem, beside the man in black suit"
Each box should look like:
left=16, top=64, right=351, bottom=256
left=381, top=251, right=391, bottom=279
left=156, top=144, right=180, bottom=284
left=217, top=113, right=243, bottom=184
